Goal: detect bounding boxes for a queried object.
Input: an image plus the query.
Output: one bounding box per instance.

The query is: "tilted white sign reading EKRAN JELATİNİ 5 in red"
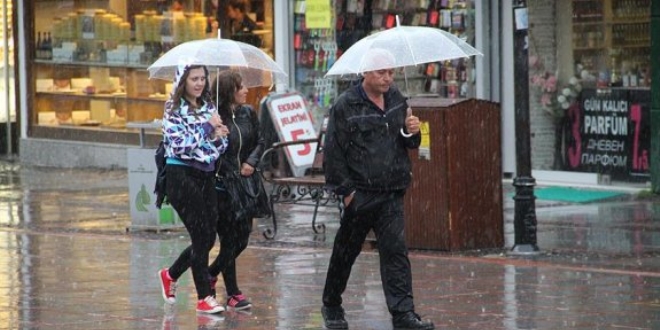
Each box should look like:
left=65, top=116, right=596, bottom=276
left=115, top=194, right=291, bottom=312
left=266, top=93, right=317, bottom=176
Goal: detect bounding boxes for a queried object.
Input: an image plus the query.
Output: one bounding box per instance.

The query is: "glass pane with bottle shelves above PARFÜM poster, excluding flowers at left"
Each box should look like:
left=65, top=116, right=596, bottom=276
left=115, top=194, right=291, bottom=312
left=565, top=0, right=651, bottom=181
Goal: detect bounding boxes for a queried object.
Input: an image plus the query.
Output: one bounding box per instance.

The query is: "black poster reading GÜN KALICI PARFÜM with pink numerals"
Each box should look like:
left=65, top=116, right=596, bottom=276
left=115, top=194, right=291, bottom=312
left=564, top=89, right=651, bottom=181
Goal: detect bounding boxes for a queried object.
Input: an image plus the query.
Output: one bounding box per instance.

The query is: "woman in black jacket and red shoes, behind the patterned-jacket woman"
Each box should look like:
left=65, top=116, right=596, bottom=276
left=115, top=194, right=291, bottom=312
left=209, top=70, right=264, bottom=310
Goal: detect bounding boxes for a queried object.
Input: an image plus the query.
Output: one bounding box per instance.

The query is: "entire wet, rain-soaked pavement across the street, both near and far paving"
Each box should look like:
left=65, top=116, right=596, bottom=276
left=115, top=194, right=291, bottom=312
left=0, top=162, right=660, bottom=330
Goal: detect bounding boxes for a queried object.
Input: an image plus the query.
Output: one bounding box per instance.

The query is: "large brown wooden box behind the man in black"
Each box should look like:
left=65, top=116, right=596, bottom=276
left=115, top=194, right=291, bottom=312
left=404, top=98, right=504, bottom=251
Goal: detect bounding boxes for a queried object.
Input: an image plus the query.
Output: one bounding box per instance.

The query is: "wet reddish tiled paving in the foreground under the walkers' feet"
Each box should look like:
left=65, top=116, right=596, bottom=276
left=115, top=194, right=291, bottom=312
left=0, top=231, right=660, bottom=329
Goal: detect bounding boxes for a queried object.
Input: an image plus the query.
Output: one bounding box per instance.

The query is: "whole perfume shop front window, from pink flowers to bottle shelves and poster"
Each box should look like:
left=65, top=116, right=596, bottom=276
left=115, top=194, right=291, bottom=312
left=530, top=0, right=651, bottom=181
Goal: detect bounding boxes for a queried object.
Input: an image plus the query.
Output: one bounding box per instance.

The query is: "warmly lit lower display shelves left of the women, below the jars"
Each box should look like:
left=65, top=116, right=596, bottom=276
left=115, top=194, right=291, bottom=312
left=33, top=60, right=171, bottom=128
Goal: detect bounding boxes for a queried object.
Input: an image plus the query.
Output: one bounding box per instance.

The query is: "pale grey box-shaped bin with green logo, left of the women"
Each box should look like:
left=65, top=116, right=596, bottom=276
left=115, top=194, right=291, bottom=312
left=126, top=122, right=184, bottom=231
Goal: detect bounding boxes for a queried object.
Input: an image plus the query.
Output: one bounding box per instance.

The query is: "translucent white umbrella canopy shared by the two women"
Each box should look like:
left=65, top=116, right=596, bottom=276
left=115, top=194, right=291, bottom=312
left=147, top=38, right=288, bottom=87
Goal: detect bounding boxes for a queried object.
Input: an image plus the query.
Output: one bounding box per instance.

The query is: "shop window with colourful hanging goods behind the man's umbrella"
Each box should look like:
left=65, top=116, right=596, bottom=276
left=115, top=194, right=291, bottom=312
left=291, top=0, right=476, bottom=126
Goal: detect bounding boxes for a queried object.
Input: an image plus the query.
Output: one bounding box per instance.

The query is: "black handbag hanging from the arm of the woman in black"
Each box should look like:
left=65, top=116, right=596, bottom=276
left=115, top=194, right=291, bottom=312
left=217, top=171, right=272, bottom=219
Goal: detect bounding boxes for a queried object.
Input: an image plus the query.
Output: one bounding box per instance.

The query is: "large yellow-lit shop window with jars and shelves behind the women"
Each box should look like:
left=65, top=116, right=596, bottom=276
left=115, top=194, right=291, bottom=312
left=26, top=0, right=273, bottom=142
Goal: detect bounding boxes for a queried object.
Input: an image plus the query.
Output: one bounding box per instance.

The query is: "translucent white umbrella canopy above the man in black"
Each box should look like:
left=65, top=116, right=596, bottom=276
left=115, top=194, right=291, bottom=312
left=325, top=21, right=483, bottom=76
